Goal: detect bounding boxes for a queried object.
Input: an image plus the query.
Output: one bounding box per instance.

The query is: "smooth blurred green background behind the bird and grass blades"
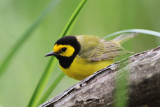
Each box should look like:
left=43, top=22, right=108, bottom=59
left=0, top=0, right=160, bottom=107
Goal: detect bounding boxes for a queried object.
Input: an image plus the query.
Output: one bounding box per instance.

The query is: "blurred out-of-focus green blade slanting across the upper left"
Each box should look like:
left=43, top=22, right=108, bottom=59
left=0, top=0, right=61, bottom=76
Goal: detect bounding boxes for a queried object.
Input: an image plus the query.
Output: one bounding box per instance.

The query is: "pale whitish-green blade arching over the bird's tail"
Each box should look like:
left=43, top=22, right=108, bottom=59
left=104, top=29, right=160, bottom=38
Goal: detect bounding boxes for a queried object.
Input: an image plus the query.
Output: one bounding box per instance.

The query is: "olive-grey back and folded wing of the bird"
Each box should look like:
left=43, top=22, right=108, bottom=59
left=79, top=36, right=129, bottom=61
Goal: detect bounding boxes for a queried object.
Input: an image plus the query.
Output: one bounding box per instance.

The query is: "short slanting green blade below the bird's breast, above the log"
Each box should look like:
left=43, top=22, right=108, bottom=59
left=39, top=72, right=65, bottom=104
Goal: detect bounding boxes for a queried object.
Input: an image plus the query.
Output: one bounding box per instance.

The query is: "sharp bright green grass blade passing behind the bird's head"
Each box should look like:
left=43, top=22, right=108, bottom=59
left=28, top=0, right=87, bottom=107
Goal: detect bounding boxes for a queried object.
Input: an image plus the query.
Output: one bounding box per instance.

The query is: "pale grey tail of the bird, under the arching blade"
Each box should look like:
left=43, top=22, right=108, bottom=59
left=112, top=33, right=138, bottom=44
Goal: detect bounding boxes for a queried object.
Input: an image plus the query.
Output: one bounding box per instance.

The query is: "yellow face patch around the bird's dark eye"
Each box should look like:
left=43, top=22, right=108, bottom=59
left=53, top=44, right=75, bottom=57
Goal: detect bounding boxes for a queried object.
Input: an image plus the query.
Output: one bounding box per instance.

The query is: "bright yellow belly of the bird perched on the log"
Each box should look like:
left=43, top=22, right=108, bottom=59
left=61, top=55, right=113, bottom=80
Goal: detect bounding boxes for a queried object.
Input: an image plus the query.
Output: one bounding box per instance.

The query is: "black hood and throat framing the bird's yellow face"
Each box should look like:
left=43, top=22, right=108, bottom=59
left=55, top=36, right=81, bottom=69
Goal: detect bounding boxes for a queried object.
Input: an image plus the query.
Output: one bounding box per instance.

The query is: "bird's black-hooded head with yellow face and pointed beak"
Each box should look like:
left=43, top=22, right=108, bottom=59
left=46, top=36, right=80, bottom=66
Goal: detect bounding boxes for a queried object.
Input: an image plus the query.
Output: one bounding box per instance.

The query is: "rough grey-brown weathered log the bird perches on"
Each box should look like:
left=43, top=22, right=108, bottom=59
left=40, top=47, right=160, bottom=107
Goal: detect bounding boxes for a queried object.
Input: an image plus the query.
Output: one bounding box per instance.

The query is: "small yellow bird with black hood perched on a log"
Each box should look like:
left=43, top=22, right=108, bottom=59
left=46, top=33, right=136, bottom=80
